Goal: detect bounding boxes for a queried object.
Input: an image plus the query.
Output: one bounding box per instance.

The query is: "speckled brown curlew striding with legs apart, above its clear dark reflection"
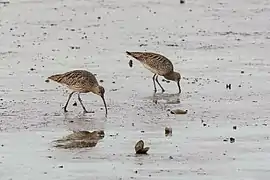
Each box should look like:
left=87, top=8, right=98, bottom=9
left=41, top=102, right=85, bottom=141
left=48, top=70, right=107, bottom=116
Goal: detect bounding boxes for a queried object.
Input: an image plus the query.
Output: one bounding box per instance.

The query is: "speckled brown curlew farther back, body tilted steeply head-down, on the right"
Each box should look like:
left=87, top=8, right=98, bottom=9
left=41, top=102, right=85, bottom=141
left=126, top=51, right=181, bottom=93
